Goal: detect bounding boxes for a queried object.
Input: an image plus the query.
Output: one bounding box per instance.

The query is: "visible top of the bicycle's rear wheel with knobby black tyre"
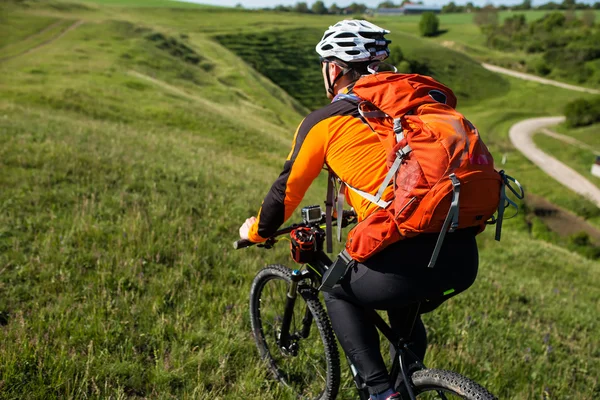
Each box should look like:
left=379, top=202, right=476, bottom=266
left=412, top=369, right=498, bottom=400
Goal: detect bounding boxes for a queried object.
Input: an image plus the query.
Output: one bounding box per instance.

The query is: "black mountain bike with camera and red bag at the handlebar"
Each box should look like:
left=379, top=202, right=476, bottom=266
left=234, top=206, right=497, bottom=400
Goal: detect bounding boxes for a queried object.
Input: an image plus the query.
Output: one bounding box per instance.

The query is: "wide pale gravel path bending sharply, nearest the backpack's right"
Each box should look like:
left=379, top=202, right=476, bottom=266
left=508, top=117, right=600, bottom=207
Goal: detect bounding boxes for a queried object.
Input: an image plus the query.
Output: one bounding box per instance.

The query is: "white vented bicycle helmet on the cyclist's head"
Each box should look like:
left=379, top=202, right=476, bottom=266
left=316, top=20, right=391, bottom=63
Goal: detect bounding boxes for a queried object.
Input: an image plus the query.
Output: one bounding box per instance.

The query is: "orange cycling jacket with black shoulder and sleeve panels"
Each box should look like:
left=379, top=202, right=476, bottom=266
left=249, top=96, right=393, bottom=242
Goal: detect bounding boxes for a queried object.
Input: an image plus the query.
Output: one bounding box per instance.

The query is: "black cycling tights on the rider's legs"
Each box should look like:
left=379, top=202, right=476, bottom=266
left=325, top=230, right=478, bottom=394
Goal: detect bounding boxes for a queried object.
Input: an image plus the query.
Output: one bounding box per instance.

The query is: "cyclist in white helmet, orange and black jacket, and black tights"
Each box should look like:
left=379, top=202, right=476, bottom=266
left=239, top=20, right=478, bottom=400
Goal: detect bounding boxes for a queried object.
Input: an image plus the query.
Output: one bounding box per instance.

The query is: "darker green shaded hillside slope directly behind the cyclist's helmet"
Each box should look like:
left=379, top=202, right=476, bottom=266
left=216, top=28, right=508, bottom=109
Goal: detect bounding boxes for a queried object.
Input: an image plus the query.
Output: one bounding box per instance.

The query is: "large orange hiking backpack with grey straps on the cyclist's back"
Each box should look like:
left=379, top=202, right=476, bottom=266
left=328, top=72, right=523, bottom=267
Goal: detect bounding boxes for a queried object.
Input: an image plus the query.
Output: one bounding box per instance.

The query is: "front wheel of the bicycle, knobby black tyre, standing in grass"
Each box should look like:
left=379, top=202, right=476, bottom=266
left=250, top=265, right=340, bottom=400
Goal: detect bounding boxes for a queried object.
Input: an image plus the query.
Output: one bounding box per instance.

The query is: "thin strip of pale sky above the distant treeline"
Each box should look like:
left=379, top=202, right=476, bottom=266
left=180, top=0, right=584, bottom=8
